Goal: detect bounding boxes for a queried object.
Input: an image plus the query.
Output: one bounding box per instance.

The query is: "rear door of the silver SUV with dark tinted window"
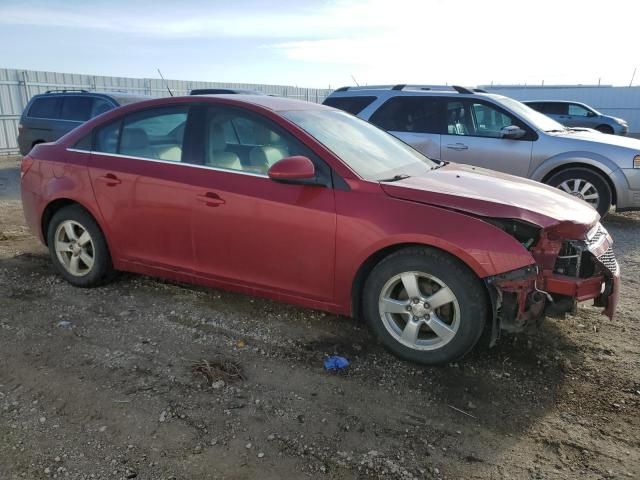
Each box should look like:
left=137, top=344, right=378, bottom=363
left=369, top=95, right=444, bottom=160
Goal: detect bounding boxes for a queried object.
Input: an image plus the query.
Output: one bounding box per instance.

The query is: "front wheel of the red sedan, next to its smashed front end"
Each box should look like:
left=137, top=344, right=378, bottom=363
left=363, top=247, right=488, bottom=365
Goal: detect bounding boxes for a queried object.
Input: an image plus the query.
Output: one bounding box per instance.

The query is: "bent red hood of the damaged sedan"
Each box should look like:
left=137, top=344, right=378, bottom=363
left=381, top=163, right=599, bottom=234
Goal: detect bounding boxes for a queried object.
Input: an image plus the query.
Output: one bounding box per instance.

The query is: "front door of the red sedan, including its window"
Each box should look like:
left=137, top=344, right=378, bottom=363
left=188, top=106, right=336, bottom=301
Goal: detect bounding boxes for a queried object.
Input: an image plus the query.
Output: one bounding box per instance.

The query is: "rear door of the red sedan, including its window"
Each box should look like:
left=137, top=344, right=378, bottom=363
left=88, top=105, right=195, bottom=271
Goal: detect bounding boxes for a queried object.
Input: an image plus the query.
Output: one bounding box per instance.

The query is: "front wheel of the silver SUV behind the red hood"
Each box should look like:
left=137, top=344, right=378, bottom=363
left=547, top=168, right=612, bottom=217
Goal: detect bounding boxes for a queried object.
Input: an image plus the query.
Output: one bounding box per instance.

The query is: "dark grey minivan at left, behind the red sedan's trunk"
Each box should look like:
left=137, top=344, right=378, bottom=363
left=18, top=90, right=151, bottom=155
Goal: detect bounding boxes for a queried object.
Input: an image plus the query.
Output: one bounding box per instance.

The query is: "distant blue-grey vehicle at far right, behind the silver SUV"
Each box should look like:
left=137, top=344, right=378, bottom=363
left=522, top=100, right=629, bottom=135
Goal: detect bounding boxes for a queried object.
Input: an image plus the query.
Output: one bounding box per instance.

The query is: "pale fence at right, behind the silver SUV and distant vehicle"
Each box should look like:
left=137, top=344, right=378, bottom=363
left=481, top=85, right=640, bottom=137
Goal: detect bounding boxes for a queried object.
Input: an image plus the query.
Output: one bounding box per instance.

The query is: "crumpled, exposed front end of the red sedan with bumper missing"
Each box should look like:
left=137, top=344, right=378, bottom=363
left=485, top=222, right=620, bottom=331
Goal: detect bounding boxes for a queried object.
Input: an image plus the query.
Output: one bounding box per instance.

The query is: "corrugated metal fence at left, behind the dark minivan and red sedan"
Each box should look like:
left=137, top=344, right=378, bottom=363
left=0, top=68, right=331, bottom=154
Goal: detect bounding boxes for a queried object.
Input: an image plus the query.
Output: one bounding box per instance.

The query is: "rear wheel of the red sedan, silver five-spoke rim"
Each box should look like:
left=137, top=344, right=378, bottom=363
left=47, top=205, right=113, bottom=288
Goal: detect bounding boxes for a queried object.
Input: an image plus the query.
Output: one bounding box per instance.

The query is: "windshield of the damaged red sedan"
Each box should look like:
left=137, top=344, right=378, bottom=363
left=281, top=109, right=436, bottom=181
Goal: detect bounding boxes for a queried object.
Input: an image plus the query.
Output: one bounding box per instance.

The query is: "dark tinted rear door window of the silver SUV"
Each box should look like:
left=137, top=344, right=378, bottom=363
left=369, top=96, right=442, bottom=133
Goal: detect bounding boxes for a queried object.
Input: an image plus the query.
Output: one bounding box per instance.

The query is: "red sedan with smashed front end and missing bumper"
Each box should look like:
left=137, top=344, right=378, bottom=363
left=22, top=95, right=619, bottom=364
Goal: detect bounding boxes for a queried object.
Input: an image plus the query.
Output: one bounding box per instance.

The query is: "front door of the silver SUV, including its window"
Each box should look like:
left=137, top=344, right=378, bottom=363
left=442, top=97, right=537, bottom=177
